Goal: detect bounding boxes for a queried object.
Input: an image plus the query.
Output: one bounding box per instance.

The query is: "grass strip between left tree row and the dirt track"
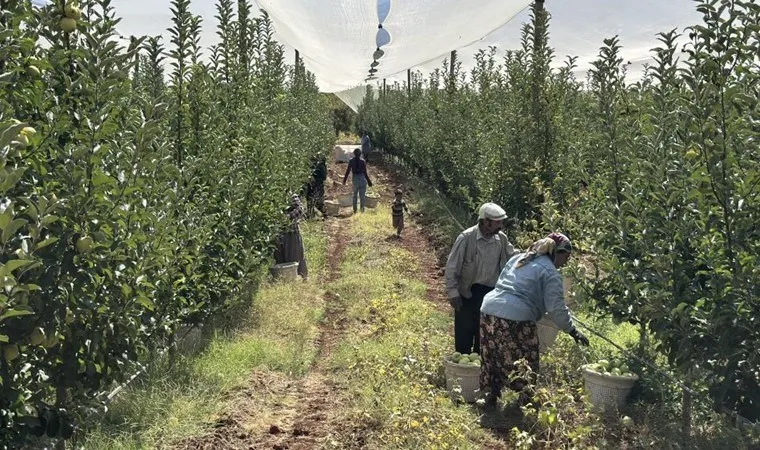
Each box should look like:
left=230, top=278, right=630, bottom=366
left=83, top=223, right=327, bottom=450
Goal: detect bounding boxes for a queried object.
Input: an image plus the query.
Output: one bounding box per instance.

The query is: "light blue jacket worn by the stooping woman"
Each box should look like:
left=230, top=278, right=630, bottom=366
left=480, top=253, right=573, bottom=331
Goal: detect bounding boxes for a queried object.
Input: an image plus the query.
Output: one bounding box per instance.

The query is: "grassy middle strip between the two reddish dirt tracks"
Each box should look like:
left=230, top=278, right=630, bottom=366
left=330, top=206, right=494, bottom=449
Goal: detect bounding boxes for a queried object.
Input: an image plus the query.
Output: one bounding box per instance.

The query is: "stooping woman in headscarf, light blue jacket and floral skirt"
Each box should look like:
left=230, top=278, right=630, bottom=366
left=480, top=233, right=588, bottom=406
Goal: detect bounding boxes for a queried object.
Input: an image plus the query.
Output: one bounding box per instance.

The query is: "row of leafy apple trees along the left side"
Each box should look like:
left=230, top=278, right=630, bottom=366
left=0, top=0, right=333, bottom=443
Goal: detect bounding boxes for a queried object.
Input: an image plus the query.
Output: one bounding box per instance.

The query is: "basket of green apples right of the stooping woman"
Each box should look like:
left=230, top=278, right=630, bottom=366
left=581, top=359, right=639, bottom=409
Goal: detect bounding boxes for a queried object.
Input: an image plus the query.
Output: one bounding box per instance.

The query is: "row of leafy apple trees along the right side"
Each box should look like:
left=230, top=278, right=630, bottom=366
left=358, top=0, right=760, bottom=420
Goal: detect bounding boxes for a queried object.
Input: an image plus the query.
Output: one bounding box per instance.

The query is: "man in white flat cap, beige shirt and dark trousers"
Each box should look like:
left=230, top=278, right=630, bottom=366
left=445, top=203, right=515, bottom=354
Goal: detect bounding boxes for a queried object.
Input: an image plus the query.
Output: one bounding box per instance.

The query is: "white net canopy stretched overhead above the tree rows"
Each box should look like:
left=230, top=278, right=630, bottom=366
left=84, top=0, right=700, bottom=106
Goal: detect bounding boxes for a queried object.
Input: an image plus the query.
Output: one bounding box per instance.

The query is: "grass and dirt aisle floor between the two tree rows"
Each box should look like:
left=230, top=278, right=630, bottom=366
left=84, top=153, right=756, bottom=450
